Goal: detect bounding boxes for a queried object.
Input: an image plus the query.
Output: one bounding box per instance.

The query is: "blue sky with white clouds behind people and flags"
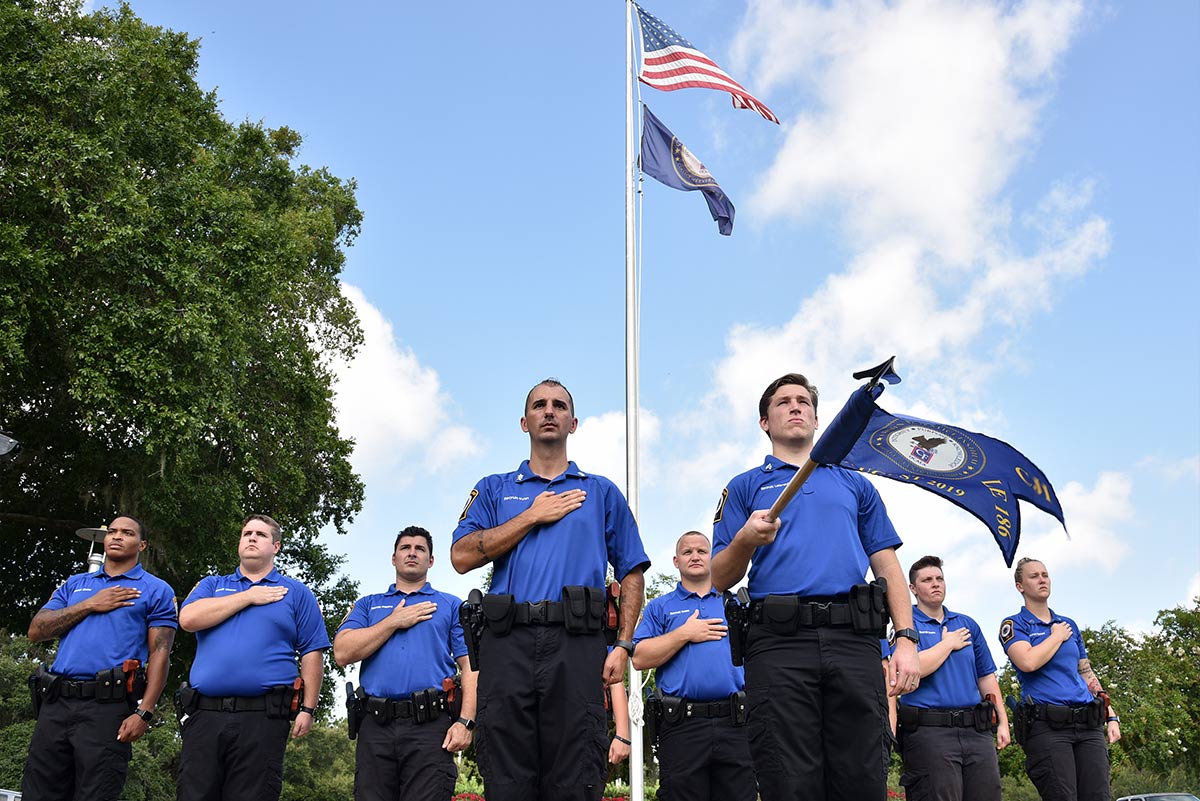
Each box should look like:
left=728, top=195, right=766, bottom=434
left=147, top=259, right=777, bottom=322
left=114, top=0, right=1200, bottom=650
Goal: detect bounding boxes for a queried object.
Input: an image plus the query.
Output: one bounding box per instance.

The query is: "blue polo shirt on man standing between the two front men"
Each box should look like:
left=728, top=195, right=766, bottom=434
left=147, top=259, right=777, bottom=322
left=634, top=584, right=745, bottom=701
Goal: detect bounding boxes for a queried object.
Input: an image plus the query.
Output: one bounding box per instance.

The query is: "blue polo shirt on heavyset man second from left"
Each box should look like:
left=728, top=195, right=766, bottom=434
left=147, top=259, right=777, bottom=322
left=184, top=567, right=329, bottom=697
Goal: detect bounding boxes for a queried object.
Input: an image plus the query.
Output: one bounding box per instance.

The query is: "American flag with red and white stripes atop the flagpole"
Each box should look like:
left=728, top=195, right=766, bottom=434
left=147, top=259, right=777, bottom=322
left=634, top=4, right=779, bottom=124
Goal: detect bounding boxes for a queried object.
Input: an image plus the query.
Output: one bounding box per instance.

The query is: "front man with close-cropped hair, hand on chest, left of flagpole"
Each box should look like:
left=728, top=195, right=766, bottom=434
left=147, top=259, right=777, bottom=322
left=450, top=379, right=650, bottom=801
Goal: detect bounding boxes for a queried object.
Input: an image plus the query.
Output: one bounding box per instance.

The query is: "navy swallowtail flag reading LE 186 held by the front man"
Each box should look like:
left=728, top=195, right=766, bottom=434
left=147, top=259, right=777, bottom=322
left=810, top=360, right=1067, bottom=567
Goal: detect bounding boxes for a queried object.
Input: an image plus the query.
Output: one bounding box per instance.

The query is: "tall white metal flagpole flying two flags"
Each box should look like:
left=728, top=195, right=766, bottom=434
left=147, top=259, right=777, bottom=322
left=625, top=0, right=646, bottom=801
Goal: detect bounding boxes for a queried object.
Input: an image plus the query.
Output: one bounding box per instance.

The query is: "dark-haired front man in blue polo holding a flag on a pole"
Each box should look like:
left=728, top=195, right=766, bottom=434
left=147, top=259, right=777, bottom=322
left=713, top=373, right=920, bottom=801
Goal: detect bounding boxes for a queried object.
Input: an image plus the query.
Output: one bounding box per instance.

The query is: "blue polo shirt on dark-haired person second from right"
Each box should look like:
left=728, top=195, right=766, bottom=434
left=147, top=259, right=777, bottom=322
left=900, top=604, right=1001, bottom=709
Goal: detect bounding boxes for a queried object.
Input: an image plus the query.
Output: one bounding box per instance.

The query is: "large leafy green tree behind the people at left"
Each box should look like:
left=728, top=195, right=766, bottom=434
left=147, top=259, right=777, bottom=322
left=0, top=0, right=362, bottom=700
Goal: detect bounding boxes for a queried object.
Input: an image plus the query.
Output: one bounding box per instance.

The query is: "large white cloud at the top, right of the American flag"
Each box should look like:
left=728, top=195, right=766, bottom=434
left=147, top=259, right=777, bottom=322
left=734, top=0, right=1082, bottom=265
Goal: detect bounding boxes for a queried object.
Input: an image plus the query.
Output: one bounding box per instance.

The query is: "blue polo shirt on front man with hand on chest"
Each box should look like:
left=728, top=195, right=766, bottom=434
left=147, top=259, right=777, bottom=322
left=454, top=459, right=650, bottom=602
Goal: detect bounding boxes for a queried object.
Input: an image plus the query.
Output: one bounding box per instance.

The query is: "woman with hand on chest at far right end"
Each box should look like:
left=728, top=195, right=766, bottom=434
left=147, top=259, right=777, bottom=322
left=1000, top=559, right=1121, bottom=801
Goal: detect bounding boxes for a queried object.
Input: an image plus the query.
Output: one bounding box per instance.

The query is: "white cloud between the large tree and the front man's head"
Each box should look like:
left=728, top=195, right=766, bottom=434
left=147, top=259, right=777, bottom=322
left=332, top=284, right=479, bottom=486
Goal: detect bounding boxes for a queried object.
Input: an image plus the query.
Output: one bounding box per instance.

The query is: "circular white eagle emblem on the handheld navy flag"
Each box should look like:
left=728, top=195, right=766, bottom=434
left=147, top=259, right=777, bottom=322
left=871, top=420, right=986, bottom=478
